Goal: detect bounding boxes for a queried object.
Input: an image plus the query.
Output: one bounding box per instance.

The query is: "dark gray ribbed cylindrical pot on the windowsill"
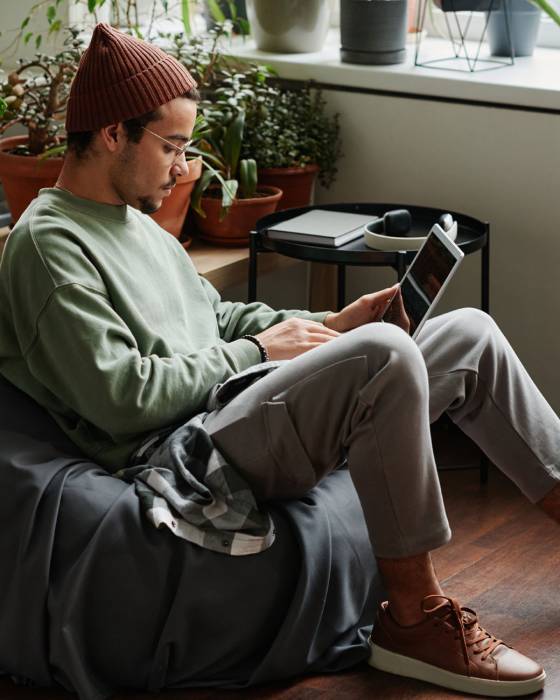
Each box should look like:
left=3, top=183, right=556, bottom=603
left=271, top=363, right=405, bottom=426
left=340, top=0, right=407, bottom=64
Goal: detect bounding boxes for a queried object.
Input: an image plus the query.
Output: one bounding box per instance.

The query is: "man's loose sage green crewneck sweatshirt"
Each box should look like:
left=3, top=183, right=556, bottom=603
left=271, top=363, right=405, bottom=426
left=0, top=189, right=326, bottom=471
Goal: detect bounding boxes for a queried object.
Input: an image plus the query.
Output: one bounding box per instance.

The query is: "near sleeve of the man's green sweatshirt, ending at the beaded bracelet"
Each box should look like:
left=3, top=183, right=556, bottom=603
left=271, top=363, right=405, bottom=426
left=25, top=284, right=260, bottom=440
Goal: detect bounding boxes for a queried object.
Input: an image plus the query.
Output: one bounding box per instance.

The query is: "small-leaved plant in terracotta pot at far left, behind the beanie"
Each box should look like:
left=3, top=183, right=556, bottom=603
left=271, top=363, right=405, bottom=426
left=0, top=29, right=82, bottom=223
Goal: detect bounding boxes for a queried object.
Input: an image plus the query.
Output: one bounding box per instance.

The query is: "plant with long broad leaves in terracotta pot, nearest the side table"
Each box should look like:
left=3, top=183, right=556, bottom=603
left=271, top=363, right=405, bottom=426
left=192, top=110, right=282, bottom=246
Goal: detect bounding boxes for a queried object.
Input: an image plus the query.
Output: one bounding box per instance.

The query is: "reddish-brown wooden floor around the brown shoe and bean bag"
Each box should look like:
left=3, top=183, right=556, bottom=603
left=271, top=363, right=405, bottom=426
left=0, top=470, right=560, bottom=700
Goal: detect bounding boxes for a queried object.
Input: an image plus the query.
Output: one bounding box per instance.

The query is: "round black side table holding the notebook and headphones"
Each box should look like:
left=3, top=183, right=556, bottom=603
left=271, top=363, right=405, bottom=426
left=248, top=202, right=490, bottom=313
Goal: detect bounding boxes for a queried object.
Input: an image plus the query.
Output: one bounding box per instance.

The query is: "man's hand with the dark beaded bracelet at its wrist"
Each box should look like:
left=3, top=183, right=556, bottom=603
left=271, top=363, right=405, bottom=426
left=255, top=318, right=340, bottom=360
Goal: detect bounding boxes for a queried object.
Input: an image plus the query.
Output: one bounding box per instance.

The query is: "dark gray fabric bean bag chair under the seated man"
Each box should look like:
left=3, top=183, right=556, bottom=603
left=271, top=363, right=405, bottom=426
left=0, top=378, right=382, bottom=700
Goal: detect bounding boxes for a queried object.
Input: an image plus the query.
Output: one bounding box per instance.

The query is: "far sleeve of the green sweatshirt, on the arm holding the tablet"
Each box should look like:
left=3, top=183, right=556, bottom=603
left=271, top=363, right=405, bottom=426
left=200, top=277, right=330, bottom=342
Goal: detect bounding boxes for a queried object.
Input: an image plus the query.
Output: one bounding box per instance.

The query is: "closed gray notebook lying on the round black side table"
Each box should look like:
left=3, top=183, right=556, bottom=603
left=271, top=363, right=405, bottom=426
left=268, top=209, right=379, bottom=248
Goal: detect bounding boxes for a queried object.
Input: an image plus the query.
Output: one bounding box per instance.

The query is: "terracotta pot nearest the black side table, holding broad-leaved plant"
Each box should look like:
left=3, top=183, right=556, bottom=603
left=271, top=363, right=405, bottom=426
left=196, top=186, right=282, bottom=246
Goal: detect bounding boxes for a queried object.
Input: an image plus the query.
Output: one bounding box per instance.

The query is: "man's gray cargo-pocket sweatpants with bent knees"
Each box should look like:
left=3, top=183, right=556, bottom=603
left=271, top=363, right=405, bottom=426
left=205, top=309, right=560, bottom=557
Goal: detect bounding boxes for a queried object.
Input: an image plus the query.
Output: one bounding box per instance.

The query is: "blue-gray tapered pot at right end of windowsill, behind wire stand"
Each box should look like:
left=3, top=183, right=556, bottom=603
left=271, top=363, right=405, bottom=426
left=488, top=0, right=541, bottom=56
